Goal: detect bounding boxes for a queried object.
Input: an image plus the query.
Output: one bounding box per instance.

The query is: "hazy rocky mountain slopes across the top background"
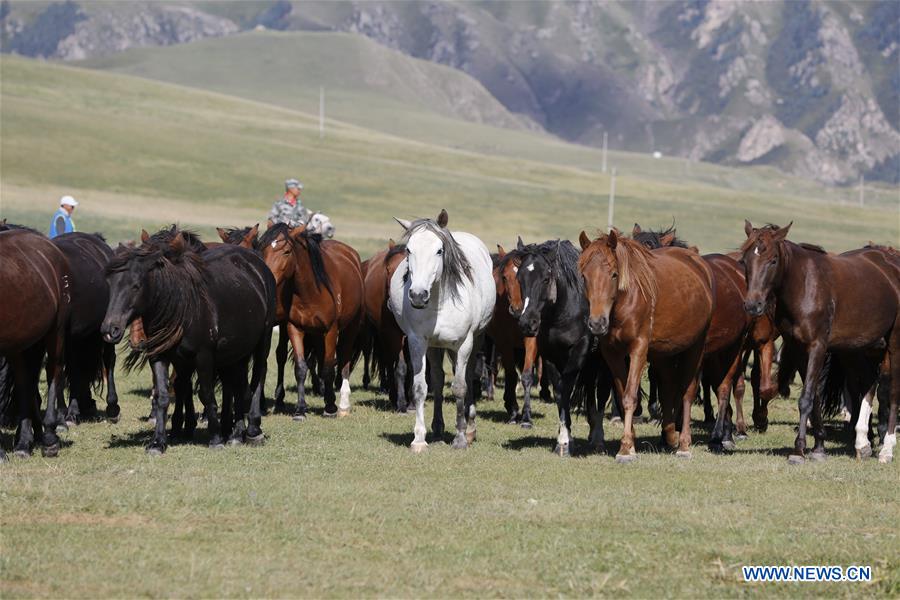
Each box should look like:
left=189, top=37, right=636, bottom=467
left=0, top=0, right=900, bottom=183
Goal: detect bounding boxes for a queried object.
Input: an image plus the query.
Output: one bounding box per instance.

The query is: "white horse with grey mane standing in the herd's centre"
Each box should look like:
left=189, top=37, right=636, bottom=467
left=388, top=210, right=497, bottom=452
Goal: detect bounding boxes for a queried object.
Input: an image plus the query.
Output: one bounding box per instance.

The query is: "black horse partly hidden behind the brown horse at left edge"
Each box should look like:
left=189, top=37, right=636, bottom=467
left=52, top=233, right=119, bottom=424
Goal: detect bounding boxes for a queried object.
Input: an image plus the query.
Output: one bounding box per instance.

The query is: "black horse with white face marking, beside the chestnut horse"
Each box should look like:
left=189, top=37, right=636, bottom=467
left=503, top=238, right=611, bottom=456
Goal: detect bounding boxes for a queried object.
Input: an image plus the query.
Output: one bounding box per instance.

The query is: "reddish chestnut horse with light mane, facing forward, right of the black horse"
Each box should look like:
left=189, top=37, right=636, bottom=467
left=578, top=230, right=714, bottom=462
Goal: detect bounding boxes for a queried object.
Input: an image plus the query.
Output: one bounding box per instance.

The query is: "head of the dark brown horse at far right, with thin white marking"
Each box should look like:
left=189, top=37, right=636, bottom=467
left=741, top=221, right=793, bottom=317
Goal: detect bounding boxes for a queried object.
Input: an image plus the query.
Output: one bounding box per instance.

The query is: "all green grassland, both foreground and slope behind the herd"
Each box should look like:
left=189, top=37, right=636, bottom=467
left=0, top=56, right=900, bottom=597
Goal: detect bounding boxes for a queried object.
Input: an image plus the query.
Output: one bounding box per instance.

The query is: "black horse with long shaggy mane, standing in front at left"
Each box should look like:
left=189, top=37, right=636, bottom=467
left=102, top=229, right=275, bottom=454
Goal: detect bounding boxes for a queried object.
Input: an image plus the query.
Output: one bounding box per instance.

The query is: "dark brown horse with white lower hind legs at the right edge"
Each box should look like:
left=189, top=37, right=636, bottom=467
left=741, top=221, right=900, bottom=463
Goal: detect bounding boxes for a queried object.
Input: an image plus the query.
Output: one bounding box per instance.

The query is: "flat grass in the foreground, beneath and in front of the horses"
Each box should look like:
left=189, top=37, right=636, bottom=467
left=0, top=350, right=900, bottom=598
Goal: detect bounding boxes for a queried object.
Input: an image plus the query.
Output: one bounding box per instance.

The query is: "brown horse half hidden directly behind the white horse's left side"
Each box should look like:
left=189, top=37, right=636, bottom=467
left=363, top=240, right=415, bottom=412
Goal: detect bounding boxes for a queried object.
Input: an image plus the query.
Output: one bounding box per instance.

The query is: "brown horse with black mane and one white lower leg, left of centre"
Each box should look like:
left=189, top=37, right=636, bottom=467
left=259, top=223, right=365, bottom=421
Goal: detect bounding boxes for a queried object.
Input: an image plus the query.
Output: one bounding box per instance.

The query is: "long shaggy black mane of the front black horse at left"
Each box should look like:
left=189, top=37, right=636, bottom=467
left=106, top=229, right=212, bottom=360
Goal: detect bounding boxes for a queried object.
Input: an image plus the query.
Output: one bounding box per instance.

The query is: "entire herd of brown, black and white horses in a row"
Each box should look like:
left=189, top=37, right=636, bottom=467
left=0, top=211, right=900, bottom=463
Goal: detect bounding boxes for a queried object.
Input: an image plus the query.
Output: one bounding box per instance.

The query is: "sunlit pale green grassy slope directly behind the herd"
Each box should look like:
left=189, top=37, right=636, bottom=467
left=0, top=52, right=898, bottom=254
